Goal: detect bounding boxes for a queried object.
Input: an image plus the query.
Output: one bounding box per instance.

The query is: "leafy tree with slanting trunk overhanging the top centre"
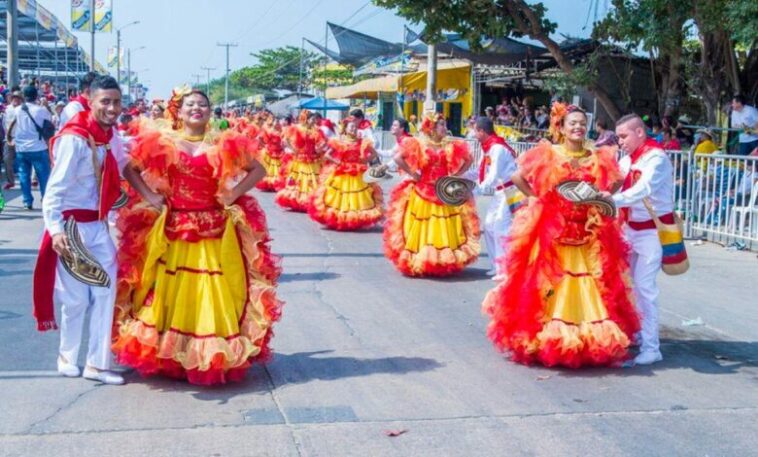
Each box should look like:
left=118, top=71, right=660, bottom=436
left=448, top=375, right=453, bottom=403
left=374, top=0, right=621, bottom=119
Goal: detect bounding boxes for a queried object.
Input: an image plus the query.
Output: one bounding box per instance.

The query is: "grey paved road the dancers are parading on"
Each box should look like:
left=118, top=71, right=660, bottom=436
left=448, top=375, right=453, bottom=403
left=0, top=183, right=758, bottom=457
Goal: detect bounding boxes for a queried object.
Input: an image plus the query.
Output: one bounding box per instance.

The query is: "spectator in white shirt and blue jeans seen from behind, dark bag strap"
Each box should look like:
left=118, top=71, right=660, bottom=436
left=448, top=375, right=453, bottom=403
left=11, top=86, right=53, bottom=210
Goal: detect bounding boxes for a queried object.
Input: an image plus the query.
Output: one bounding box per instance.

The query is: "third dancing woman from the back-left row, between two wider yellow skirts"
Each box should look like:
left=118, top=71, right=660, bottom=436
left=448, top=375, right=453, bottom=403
left=276, top=111, right=326, bottom=212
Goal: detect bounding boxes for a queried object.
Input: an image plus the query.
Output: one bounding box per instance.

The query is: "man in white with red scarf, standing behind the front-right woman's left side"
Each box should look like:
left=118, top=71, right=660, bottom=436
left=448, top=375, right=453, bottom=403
left=474, top=117, right=523, bottom=281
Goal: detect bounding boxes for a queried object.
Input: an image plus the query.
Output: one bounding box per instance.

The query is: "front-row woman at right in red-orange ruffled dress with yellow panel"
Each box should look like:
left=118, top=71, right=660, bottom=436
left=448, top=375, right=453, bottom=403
left=483, top=103, right=639, bottom=368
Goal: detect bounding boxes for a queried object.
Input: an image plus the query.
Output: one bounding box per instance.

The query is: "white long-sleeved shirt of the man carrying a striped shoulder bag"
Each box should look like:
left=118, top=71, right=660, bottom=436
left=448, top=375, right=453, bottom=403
left=613, top=149, right=674, bottom=222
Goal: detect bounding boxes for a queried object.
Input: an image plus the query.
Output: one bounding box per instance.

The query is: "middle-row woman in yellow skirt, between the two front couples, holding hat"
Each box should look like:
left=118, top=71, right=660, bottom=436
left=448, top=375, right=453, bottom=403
left=384, top=115, right=480, bottom=276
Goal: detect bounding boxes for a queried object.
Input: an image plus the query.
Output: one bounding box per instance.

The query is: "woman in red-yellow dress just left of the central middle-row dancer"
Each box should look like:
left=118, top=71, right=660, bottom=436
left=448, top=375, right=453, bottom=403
left=308, top=122, right=383, bottom=230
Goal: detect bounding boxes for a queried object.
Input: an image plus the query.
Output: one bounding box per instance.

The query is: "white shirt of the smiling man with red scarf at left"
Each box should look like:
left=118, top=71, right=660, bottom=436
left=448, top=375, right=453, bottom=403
left=42, top=130, right=129, bottom=236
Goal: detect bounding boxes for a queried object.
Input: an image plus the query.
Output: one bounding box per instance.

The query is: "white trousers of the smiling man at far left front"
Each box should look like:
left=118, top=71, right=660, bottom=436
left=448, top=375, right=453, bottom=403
left=55, top=221, right=117, bottom=370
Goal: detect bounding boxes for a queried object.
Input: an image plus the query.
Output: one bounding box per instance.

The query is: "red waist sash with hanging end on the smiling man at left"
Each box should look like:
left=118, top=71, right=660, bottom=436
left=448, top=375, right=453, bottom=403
left=32, top=209, right=100, bottom=332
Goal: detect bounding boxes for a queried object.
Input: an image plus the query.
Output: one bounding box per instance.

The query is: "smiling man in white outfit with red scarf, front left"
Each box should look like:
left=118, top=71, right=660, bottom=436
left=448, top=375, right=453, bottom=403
left=34, top=76, right=127, bottom=384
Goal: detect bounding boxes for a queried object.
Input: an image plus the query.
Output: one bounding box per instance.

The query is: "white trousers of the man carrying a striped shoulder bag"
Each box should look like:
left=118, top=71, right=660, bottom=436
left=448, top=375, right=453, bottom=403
left=626, top=227, right=663, bottom=352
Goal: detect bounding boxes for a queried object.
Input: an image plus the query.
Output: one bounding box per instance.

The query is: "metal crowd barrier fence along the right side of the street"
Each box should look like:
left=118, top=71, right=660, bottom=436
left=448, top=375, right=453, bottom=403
left=374, top=132, right=758, bottom=250
